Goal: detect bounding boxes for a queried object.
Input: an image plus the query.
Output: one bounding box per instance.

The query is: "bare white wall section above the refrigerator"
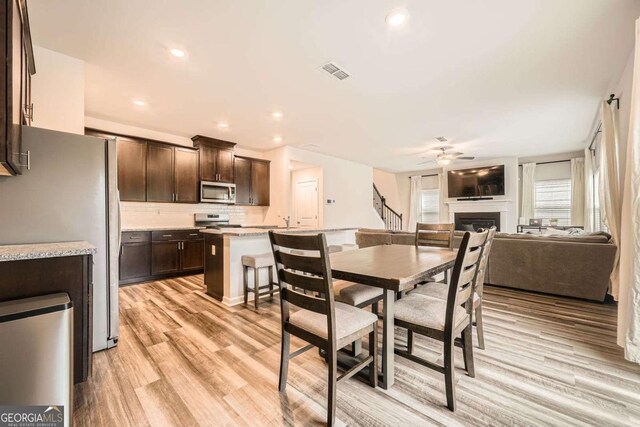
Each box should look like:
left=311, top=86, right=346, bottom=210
left=31, top=46, right=84, bottom=134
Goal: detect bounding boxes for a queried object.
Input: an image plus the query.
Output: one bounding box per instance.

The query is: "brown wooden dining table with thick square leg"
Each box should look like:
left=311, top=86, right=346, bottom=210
left=330, top=245, right=457, bottom=389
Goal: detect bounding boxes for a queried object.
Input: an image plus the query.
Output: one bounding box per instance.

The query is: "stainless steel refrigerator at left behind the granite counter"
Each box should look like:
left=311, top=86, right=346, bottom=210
left=0, top=126, right=120, bottom=351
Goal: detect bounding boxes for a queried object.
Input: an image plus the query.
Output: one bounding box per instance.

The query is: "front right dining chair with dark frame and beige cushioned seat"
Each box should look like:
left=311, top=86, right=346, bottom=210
left=394, top=231, right=489, bottom=411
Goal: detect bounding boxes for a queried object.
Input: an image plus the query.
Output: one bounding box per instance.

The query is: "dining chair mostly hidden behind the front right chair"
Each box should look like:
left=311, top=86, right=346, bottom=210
left=411, top=227, right=496, bottom=350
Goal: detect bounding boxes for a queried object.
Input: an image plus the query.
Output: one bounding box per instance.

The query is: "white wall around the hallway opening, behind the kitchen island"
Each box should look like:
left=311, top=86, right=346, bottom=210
left=265, top=147, right=383, bottom=228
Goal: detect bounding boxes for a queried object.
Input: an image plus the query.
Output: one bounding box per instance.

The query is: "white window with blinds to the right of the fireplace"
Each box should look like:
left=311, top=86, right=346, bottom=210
left=535, top=179, right=571, bottom=225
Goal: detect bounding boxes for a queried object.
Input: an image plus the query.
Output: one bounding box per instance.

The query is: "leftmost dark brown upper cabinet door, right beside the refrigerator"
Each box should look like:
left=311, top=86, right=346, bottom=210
left=117, top=137, right=147, bottom=202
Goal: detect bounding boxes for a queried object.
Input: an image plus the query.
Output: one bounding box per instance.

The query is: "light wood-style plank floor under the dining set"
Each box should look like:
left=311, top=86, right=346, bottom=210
left=74, top=276, right=640, bottom=426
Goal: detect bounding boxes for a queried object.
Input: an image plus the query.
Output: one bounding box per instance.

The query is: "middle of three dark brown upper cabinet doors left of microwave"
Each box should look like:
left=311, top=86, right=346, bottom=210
left=146, top=144, right=175, bottom=202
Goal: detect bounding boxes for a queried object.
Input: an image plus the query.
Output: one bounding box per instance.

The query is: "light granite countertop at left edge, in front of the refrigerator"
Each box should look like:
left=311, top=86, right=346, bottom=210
left=0, top=242, right=98, bottom=262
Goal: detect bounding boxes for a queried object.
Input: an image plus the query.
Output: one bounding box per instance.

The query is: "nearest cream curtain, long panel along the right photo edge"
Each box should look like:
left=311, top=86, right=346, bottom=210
left=618, top=19, right=640, bottom=363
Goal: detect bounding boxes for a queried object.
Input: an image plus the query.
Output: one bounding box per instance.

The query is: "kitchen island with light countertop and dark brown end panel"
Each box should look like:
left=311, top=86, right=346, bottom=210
left=200, top=228, right=357, bottom=306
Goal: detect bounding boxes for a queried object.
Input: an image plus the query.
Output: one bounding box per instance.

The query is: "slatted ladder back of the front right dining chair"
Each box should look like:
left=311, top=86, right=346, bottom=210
left=445, top=231, right=489, bottom=333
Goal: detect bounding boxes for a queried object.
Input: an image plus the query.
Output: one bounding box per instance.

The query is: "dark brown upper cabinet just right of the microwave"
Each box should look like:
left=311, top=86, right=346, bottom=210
left=235, top=156, right=270, bottom=206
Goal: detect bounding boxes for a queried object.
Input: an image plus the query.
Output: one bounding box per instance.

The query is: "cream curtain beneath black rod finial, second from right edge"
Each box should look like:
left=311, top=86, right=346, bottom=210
left=597, top=101, right=622, bottom=301
